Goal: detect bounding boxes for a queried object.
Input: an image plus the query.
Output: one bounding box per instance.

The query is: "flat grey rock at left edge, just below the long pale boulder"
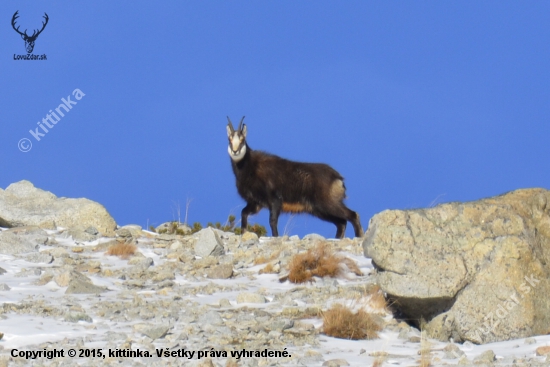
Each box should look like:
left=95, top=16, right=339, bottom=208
left=0, top=226, right=48, bottom=255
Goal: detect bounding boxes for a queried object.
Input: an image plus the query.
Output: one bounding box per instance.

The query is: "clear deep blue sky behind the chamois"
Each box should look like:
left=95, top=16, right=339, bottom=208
left=0, top=0, right=550, bottom=237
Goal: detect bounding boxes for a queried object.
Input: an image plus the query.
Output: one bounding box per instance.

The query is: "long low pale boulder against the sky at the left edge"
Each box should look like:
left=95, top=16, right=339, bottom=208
left=0, top=181, right=116, bottom=236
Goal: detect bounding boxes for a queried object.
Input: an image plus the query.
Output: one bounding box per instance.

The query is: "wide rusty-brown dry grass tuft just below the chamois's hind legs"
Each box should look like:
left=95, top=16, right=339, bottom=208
left=288, top=243, right=362, bottom=283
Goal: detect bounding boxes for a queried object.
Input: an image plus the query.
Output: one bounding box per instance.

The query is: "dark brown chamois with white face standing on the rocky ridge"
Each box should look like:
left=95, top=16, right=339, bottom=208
left=227, top=117, right=363, bottom=238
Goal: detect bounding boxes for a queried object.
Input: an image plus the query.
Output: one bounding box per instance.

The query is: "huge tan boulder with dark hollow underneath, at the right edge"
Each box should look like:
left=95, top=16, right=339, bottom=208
left=363, top=189, right=550, bottom=343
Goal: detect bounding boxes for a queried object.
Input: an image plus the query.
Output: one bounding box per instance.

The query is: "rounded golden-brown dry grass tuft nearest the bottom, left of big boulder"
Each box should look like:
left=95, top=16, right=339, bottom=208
left=323, top=304, right=382, bottom=340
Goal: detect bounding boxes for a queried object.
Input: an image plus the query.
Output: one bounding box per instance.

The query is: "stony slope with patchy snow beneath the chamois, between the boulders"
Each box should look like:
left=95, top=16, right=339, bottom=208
left=0, top=226, right=550, bottom=367
